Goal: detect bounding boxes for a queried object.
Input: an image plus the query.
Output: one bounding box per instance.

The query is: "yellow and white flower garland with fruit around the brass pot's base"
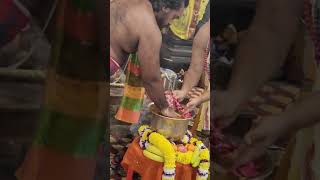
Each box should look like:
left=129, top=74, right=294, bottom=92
left=138, top=125, right=210, bottom=180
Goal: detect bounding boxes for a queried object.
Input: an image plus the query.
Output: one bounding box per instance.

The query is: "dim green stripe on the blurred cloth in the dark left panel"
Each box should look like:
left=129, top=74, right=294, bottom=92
left=35, top=108, right=105, bottom=157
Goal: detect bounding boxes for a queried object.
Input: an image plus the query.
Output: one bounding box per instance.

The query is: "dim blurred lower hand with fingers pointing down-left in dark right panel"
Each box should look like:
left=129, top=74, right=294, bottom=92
left=231, top=116, right=290, bottom=169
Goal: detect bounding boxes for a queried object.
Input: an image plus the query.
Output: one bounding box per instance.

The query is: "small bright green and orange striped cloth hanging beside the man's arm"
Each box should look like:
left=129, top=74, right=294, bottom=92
left=115, top=54, right=145, bottom=124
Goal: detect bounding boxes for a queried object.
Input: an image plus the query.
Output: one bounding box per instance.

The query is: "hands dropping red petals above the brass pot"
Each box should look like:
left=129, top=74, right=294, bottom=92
left=162, top=88, right=202, bottom=117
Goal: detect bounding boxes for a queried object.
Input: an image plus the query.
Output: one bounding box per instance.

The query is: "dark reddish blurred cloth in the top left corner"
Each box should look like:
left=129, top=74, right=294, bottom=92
left=0, top=0, right=29, bottom=48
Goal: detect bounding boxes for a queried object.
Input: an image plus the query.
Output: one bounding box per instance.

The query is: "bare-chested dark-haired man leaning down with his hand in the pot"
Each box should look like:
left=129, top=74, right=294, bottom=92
left=110, top=0, right=188, bottom=117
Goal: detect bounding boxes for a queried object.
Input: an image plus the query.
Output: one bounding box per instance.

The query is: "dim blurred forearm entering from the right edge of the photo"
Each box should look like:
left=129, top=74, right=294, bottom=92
left=279, top=92, right=320, bottom=131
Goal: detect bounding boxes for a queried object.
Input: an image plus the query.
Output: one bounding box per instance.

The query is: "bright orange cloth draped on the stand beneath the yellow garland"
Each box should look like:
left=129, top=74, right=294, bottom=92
left=121, top=138, right=197, bottom=180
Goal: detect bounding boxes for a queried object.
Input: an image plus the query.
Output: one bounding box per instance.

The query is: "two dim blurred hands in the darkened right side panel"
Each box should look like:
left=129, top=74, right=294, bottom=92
left=211, top=91, right=289, bottom=171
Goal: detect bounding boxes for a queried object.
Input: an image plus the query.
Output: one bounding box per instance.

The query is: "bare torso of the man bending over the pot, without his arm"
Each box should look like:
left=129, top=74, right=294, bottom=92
left=110, top=0, right=154, bottom=66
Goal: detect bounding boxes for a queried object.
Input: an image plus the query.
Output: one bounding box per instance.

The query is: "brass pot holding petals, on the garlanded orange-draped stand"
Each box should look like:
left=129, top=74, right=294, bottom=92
left=149, top=103, right=196, bottom=141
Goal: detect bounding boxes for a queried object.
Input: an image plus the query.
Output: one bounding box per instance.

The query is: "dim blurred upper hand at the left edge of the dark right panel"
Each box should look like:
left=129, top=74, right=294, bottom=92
left=211, top=91, right=241, bottom=129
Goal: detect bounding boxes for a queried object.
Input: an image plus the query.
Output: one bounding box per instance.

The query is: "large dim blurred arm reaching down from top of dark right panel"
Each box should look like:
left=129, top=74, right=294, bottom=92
left=228, top=0, right=302, bottom=105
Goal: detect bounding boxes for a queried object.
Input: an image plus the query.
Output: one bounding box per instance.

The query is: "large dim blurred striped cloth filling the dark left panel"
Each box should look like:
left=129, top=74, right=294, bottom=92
left=16, top=0, right=107, bottom=180
